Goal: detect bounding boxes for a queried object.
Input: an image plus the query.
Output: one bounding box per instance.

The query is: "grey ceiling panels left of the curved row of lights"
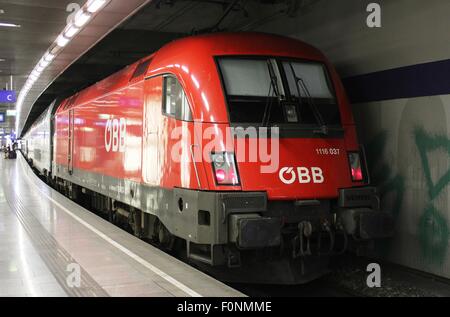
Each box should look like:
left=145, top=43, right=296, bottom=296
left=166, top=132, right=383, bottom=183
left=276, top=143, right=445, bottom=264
left=0, top=0, right=77, bottom=135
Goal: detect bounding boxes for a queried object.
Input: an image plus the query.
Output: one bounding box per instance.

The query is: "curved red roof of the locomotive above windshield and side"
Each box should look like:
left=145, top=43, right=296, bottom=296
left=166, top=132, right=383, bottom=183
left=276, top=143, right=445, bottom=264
left=57, top=32, right=325, bottom=112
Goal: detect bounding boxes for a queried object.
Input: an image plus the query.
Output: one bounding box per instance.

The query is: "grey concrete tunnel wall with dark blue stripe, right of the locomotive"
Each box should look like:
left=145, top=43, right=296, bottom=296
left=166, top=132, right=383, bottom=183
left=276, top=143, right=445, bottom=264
left=260, top=0, right=450, bottom=278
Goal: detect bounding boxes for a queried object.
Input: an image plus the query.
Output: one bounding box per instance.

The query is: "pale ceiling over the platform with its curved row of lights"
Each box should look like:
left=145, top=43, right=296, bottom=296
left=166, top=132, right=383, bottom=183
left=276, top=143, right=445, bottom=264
left=7, top=0, right=151, bottom=134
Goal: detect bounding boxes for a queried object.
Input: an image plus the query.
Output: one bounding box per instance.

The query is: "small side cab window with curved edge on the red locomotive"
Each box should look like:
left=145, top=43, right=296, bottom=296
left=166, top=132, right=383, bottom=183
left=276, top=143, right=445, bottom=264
left=163, top=76, right=192, bottom=121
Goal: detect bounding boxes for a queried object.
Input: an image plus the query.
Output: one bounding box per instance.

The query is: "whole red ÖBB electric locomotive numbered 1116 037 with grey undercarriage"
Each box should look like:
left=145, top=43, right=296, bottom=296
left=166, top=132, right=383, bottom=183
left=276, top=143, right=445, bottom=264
left=24, top=33, right=392, bottom=283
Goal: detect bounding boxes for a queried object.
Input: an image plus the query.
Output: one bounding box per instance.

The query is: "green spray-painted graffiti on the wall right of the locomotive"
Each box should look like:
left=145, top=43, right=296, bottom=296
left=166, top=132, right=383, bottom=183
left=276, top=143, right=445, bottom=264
left=367, top=127, right=450, bottom=266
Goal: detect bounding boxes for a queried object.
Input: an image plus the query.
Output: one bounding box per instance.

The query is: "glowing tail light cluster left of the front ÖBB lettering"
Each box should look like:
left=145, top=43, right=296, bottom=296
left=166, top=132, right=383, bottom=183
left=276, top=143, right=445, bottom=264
left=211, top=152, right=240, bottom=185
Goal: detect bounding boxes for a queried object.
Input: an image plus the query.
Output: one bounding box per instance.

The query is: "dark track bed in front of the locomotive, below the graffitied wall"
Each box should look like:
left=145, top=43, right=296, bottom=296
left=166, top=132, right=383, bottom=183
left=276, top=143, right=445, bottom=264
left=230, top=255, right=450, bottom=297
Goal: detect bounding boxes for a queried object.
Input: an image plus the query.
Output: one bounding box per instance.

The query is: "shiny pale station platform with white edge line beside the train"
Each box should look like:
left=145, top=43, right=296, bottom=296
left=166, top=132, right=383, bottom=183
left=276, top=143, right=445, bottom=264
left=0, top=154, right=244, bottom=297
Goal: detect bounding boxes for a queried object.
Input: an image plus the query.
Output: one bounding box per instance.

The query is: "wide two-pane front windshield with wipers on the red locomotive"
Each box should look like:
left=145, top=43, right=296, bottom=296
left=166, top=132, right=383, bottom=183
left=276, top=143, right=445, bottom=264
left=219, top=57, right=341, bottom=128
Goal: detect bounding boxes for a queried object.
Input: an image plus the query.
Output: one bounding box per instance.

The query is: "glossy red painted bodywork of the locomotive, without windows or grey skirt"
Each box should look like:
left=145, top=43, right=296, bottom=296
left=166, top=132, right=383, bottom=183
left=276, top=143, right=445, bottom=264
left=55, top=33, right=363, bottom=199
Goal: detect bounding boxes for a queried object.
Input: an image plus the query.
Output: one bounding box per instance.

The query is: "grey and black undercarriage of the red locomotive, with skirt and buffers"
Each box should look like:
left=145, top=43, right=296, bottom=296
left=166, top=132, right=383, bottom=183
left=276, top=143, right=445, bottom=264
left=50, top=165, right=393, bottom=284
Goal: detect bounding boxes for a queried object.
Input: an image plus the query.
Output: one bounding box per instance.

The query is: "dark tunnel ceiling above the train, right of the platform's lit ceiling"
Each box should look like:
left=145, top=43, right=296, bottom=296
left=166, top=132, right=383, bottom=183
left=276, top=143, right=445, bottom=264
left=23, top=0, right=318, bottom=131
